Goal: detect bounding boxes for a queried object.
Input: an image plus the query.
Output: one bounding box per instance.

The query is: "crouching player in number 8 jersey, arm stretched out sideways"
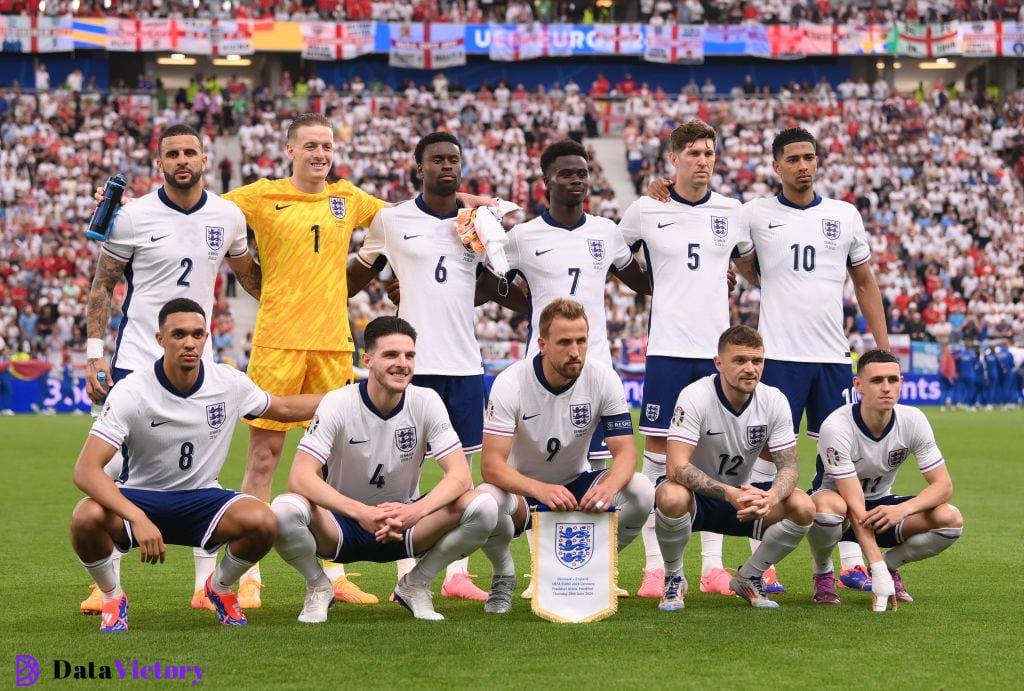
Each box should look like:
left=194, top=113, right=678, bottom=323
left=71, top=298, right=322, bottom=633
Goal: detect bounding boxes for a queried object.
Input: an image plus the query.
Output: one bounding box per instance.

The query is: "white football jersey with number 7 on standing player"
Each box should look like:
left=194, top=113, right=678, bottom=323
left=505, top=212, right=633, bottom=364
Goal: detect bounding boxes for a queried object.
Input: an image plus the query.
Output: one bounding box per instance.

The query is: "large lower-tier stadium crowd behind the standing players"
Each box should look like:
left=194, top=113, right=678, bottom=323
left=0, top=68, right=1024, bottom=407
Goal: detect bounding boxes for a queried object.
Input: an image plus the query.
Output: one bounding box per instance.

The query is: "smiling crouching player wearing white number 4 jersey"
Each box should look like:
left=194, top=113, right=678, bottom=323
left=270, top=316, right=498, bottom=623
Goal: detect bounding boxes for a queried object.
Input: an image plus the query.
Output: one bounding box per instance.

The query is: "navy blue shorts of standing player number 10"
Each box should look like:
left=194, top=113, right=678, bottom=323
left=761, top=359, right=853, bottom=438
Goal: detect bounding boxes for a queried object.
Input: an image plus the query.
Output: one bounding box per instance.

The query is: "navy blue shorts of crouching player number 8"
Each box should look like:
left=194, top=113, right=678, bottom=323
left=117, top=487, right=249, bottom=552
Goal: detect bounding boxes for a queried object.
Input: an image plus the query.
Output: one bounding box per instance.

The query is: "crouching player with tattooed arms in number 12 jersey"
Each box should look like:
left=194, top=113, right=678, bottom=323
left=654, top=326, right=814, bottom=611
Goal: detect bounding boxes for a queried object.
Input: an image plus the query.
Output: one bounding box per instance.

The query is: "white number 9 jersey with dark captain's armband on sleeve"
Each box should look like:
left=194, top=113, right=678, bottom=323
left=483, top=355, right=633, bottom=484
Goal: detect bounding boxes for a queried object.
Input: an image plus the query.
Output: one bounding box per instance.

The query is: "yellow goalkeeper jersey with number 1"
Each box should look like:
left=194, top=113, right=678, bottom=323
left=224, top=178, right=387, bottom=351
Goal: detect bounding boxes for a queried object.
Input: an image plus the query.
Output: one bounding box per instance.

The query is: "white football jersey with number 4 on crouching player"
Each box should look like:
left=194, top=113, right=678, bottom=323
left=298, top=380, right=462, bottom=506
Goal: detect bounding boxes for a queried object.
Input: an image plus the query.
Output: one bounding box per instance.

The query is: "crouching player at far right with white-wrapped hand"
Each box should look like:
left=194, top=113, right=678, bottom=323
left=807, top=350, right=964, bottom=609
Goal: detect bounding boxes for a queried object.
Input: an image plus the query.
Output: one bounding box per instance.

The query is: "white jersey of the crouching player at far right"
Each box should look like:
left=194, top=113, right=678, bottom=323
left=818, top=403, right=945, bottom=499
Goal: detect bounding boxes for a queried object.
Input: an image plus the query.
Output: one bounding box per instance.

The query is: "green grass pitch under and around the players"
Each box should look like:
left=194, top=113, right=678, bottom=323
left=0, top=412, right=1024, bottom=689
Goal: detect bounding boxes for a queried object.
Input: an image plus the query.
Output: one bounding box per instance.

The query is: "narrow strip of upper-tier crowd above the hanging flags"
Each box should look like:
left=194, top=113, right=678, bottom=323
left=25, top=0, right=1024, bottom=25
